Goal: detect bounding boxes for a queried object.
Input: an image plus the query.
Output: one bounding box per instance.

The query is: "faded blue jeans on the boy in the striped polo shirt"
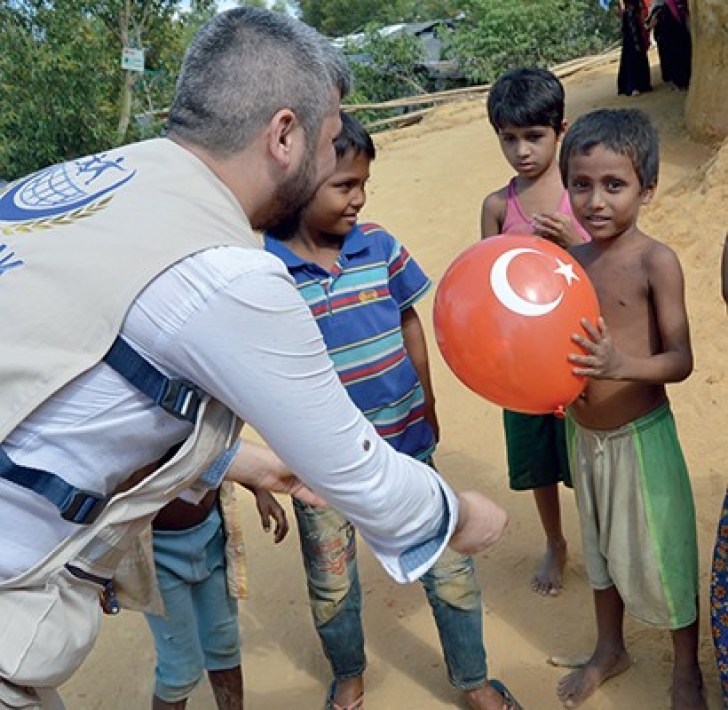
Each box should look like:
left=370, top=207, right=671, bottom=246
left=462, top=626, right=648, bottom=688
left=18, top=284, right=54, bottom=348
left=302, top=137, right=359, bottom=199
left=293, top=498, right=488, bottom=691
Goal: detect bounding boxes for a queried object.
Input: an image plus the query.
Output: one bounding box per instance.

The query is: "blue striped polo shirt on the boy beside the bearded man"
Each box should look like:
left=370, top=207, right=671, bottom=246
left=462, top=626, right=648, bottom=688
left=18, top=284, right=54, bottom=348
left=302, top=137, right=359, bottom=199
left=265, top=224, right=435, bottom=459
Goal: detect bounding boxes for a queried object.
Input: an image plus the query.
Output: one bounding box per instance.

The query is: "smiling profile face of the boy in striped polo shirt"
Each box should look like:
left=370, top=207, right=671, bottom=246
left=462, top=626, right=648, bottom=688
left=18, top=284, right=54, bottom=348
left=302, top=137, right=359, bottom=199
left=302, top=150, right=371, bottom=237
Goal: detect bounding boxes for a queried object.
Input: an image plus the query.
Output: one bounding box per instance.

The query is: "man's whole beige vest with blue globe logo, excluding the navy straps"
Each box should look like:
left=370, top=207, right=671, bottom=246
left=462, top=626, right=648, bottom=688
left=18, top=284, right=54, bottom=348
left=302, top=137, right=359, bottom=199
left=0, top=139, right=260, bottom=705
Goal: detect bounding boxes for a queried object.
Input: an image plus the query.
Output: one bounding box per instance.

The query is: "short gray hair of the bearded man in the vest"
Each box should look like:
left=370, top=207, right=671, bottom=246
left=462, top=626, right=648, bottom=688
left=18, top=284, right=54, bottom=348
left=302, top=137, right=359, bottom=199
left=169, top=7, right=351, bottom=155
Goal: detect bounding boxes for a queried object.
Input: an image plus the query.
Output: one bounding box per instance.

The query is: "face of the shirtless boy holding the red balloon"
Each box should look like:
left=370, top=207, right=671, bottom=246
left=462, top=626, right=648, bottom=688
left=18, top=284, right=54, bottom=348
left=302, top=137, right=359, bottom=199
left=567, top=145, right=655, bottom=239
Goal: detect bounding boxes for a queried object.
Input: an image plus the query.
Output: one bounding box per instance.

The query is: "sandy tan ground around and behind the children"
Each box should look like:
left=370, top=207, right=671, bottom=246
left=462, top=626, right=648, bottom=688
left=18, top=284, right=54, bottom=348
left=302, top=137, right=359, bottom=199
left=63, top=55, right=728, bottom=710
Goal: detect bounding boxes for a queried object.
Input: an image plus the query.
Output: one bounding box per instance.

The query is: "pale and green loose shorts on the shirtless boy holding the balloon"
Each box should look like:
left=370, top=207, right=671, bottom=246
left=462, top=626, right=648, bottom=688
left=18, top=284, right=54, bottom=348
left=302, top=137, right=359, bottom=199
left=567, top=404, right=698, bottom=630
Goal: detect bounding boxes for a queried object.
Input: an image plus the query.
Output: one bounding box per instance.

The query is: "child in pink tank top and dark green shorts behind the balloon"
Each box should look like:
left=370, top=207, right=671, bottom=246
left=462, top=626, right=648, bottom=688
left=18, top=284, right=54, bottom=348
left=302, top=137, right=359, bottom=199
left=480, top=67, right=589, bottom=596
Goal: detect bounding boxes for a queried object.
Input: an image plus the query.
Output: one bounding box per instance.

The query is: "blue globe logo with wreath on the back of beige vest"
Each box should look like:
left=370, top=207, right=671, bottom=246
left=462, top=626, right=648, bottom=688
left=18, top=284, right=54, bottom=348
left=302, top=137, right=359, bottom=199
left=0, top=153, right=136, bottom=234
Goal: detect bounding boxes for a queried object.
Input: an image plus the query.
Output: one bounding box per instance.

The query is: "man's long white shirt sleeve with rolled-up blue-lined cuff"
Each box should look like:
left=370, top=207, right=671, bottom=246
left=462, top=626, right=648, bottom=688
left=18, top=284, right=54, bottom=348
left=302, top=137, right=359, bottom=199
left=159, top=255, right=458, bottom=582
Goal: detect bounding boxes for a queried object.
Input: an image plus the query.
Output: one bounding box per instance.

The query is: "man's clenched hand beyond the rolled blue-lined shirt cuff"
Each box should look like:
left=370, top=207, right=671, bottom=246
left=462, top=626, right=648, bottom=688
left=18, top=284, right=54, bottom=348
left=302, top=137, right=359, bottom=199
left=450, top=491, right=508, bottom=555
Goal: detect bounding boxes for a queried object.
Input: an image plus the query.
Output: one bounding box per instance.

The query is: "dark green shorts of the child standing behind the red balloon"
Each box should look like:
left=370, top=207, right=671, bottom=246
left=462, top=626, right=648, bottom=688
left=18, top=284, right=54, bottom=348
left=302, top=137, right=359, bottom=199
left=503, top=409, right=571, bottom=491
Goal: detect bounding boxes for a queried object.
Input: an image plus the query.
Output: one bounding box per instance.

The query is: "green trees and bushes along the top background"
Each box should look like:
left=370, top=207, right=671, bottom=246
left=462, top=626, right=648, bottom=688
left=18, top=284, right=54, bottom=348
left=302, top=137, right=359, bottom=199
left=0, top=0, right=618, bottom=179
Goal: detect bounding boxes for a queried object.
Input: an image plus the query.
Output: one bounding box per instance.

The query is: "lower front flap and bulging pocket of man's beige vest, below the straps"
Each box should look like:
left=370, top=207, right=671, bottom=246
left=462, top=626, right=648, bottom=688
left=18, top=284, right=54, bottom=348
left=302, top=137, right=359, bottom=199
left=0, top=400, right=243, bottom=708
